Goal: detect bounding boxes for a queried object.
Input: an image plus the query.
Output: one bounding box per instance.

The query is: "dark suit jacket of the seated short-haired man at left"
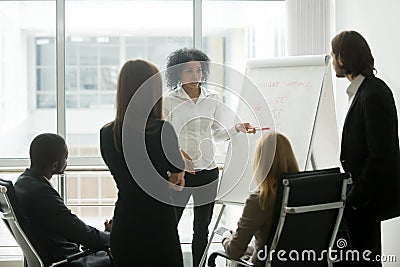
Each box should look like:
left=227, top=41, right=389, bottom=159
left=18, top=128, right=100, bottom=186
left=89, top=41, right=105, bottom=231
left=14, top=169, right=110, bottom=262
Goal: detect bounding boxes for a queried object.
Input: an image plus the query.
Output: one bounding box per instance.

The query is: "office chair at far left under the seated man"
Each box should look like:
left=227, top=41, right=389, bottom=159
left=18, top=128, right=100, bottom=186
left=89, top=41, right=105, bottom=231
left=0, top=179, right=112, bottom=267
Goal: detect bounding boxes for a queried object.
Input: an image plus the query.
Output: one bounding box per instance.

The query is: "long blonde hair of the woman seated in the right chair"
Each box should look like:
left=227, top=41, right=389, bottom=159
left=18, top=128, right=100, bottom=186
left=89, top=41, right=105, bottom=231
left=254, top=132, right=299, bottom=210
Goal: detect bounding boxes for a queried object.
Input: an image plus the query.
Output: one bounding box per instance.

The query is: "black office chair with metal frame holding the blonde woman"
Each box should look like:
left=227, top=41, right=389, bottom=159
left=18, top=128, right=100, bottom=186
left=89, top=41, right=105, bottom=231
left=208, top=168, right=351, bottom=267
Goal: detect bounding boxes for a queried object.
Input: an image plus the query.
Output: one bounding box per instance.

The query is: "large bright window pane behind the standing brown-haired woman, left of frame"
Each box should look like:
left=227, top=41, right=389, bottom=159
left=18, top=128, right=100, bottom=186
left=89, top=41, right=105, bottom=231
left=65, top=0, right=193, bottom=157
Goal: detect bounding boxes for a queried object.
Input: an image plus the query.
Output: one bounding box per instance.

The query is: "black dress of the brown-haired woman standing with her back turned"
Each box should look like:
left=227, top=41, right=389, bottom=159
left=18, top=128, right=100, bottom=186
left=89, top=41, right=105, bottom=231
left=100, top=121, right=184, bottom=267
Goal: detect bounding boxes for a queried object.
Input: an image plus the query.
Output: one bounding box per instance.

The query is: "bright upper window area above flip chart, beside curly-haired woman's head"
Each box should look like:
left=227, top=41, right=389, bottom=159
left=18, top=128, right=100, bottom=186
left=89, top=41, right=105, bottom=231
left=202, top=0, right=286, bottom=73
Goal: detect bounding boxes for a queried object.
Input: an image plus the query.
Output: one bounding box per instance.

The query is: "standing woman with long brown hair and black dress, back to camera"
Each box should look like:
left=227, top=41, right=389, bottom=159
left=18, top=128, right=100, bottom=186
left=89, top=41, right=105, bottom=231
left=100, top=60, right=184, bottom=267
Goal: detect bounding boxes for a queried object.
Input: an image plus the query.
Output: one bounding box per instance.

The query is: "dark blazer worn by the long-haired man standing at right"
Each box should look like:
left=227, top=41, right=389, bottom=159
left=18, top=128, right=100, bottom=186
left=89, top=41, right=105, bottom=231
left=340, top=76, right=400, bottom=220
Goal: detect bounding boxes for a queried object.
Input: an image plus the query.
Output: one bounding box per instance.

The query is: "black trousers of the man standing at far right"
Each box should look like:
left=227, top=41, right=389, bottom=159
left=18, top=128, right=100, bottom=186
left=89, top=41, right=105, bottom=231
left=334, top=207, right=382, bottom=267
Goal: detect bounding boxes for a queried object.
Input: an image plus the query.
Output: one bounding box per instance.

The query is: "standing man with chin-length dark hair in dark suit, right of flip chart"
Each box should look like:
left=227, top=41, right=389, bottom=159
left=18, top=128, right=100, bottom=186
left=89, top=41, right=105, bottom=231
left=331, top=31, right=400, bottom=267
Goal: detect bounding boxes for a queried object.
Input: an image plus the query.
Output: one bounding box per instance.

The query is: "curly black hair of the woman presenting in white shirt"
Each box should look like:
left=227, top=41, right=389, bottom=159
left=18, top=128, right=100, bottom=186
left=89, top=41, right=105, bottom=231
left=165, top=47, right=210, bottom=89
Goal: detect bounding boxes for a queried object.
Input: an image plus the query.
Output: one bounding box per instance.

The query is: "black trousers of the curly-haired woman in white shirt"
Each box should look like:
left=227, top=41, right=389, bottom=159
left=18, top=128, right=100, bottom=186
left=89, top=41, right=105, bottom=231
left=172, top=168, right=219, bottom=267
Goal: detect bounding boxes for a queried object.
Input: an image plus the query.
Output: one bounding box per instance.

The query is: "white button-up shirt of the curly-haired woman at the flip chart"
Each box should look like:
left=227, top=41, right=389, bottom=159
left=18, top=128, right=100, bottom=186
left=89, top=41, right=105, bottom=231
left=163, top=87, right=237, bottom=170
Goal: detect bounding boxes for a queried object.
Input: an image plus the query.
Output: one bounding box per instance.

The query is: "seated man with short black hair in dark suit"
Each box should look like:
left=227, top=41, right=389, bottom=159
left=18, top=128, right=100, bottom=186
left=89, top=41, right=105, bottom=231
left=14, top=134, right=111, bottom=266
